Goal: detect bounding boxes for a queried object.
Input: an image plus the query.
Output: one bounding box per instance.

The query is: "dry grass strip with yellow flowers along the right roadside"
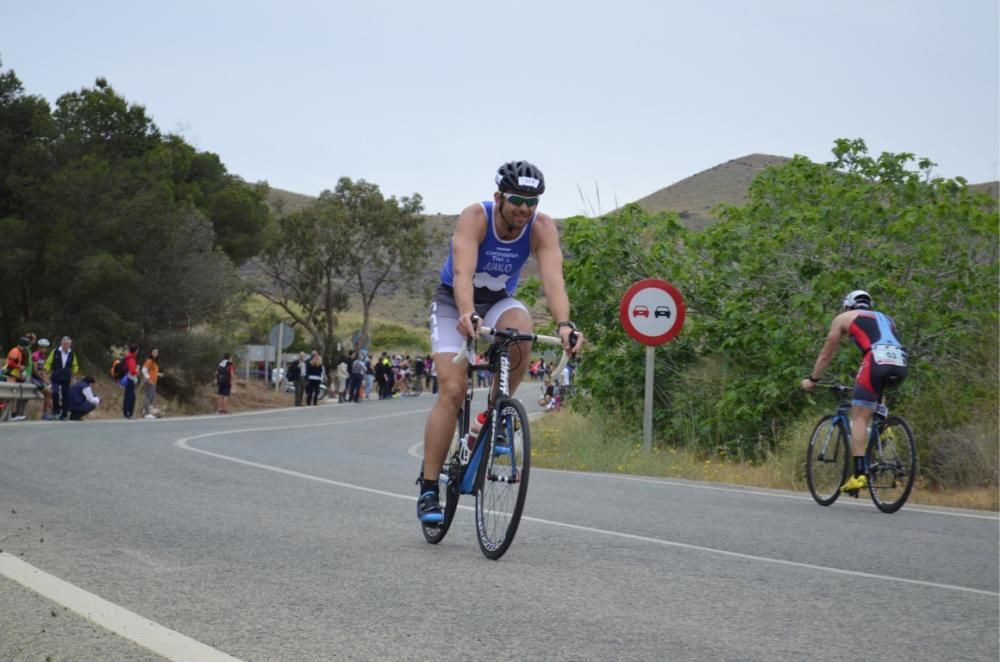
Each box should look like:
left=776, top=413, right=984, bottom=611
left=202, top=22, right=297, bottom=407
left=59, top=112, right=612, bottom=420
left=531, top=409, right=1000, bottom=511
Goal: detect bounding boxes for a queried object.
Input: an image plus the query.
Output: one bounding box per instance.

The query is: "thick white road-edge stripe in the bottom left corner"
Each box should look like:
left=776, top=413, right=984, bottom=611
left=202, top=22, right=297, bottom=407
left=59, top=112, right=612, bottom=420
left=0, top=552, right=239, bottom=662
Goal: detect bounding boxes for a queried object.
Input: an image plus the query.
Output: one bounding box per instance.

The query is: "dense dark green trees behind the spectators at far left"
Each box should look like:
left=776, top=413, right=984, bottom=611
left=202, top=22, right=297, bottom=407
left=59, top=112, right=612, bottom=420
left=0, top=65, right=267, bottom=384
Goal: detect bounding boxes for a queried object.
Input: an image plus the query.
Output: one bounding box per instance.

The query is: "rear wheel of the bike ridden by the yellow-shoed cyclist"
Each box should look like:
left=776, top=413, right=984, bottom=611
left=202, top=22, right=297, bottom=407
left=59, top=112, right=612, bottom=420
left=866, top=416, right=917, bottom=513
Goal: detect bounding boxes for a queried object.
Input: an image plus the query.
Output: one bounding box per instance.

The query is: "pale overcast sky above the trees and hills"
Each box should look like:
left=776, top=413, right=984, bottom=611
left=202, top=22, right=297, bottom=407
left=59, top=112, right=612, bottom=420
left=0, top=0, right=1000, bottom=217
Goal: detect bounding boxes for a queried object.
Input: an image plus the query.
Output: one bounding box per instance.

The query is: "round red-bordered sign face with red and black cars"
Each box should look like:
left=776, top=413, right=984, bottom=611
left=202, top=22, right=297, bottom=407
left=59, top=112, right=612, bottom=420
left=618, top=278, right=684, bottom=345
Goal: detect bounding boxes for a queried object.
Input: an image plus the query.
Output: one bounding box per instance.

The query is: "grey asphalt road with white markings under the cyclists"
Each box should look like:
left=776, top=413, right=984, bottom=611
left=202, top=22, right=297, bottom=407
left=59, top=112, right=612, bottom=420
left=0, top=395, right=1000, bottom=662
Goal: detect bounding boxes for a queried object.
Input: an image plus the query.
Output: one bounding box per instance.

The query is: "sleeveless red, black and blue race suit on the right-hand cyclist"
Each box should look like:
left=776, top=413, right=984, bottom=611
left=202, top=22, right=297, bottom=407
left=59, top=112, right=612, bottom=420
left=850, top=310, right=906, bottom=407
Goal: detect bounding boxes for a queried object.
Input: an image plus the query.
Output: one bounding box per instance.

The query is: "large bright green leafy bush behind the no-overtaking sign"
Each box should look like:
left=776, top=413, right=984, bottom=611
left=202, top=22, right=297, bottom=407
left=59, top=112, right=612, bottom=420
left=563, top=140, right=1000, bottom=466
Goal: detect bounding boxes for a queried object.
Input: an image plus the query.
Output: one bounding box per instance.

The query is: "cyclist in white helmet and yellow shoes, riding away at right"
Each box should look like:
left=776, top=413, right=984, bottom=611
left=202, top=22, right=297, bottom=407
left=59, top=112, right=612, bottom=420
left=802, top=290, right=906, bottom=492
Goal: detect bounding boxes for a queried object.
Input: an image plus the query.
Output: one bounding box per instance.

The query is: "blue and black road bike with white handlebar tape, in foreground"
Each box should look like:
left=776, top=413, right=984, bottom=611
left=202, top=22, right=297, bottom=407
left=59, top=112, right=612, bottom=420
left=418, top=326, right=575, bottom=560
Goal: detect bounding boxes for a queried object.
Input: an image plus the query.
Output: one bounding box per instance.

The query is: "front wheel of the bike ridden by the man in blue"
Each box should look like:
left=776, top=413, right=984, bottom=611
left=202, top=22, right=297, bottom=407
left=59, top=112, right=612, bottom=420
left=475, top=398, right=531, bottom=560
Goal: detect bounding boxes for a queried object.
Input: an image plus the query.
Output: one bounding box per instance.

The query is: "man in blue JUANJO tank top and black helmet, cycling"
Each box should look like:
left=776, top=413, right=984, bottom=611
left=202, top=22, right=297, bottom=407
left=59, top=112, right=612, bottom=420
left=417, top=161, right=583, bottom=525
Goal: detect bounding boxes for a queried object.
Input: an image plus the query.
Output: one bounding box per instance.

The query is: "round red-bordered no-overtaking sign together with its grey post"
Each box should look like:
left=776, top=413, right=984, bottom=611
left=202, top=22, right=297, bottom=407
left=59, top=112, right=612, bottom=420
left=618, top=278, right=685, bottom=453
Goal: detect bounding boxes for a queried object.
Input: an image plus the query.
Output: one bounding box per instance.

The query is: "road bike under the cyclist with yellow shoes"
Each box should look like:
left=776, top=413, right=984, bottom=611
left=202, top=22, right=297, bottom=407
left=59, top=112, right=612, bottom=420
left=806, top=384, right=917, bottom=513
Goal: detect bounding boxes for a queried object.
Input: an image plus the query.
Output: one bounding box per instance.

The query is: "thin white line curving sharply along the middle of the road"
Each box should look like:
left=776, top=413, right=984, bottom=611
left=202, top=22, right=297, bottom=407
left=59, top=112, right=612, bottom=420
left=174, top=420, right=1000, bottom=597
